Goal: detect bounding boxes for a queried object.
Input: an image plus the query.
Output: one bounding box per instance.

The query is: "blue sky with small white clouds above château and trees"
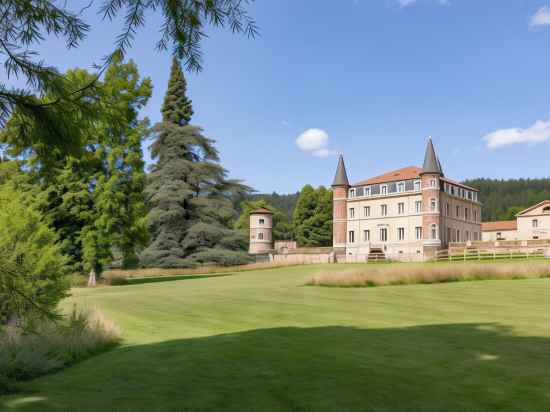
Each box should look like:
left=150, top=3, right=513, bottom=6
left=0, top=0, right=550, bottom=193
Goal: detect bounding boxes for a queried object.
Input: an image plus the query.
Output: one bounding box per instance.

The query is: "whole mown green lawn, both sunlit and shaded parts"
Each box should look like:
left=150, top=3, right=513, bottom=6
left=0, top=263, right=550, bottom=412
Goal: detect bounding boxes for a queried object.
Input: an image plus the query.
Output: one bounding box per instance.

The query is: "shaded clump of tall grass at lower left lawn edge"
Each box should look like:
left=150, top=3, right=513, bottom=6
left=0, top=309, right=120, bottom=392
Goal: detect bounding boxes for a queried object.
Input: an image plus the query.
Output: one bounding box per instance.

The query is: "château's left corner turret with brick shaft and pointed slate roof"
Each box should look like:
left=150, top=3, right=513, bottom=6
left=332, top=155, right=349, bottom=255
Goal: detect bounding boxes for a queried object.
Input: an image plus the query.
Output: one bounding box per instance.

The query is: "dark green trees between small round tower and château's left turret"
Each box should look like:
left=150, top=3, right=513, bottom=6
left=293, top=185, right=332, bottom=246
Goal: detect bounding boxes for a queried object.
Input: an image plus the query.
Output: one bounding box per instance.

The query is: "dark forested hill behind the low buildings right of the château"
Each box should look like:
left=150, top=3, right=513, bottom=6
left=464, top=178, right=550, bottom=222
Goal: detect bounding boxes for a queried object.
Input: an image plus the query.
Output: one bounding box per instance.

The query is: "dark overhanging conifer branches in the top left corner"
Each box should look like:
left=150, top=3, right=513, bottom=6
left=0, top=0, right=257, bottom=155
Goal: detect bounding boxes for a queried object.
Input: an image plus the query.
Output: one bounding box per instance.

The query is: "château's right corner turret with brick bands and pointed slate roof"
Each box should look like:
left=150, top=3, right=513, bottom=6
left=420, top=137, right=443, bottom=258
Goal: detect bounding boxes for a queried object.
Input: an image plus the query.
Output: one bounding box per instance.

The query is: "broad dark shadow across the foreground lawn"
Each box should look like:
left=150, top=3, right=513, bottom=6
left=4, top=324, right=550, bottom=412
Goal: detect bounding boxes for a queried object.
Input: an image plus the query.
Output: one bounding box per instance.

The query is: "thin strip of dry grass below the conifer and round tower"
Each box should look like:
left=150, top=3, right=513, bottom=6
left=102, top=262, right=297, bottom=284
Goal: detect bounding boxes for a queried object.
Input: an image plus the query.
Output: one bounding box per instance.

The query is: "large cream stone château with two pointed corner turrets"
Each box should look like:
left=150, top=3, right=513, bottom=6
left=332, top=138, right=482, bottom=262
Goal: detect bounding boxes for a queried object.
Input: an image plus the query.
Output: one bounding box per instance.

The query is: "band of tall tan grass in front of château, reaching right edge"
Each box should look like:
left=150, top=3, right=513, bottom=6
left=307, top=262, right=550, bottom=287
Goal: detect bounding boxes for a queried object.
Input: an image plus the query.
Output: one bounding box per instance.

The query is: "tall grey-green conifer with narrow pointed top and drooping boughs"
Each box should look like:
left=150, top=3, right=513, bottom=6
left=141, top=59, right=249, bottom=267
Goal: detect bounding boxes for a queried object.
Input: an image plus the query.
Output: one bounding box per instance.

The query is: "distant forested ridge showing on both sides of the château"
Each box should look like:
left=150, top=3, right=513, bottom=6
left=250, top=178, right=550, bottom=222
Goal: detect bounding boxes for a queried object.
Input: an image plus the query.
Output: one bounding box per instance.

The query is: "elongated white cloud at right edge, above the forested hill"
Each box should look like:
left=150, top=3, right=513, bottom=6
left=483, top=120, right=550, bottom=149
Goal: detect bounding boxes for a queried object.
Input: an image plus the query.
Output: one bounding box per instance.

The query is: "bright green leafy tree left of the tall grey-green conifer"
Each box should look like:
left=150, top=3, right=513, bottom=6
left=0, top=59, right=152, bottom=273
